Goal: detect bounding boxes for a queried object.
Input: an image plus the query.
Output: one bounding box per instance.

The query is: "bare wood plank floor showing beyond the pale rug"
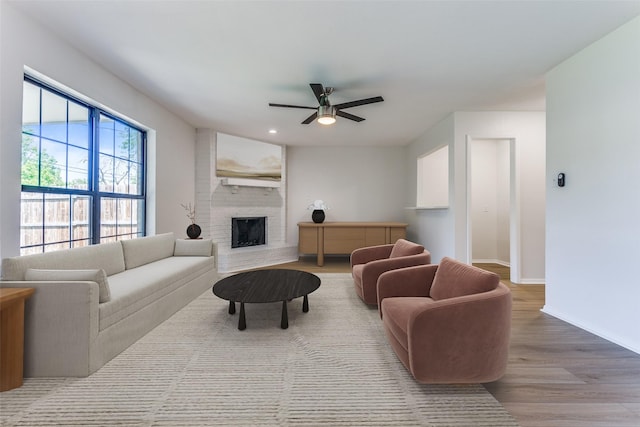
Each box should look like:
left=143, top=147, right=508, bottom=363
left=258, top=257, right=640, bottom=427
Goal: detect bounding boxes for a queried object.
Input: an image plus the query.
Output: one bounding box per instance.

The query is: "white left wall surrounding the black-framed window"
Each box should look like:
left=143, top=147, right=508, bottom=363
left=0, top=2, right=195, bottom=258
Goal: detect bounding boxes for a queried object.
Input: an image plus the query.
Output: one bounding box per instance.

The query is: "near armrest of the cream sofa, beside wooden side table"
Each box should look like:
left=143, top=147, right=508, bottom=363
left=0, top=281, right=99, bottom=377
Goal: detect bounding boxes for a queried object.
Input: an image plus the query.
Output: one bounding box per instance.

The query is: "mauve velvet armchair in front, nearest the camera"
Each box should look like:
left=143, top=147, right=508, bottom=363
left=378, top=257, right=511, bottom=384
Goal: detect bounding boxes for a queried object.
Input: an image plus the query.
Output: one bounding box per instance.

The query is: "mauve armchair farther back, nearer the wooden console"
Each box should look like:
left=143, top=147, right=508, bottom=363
left=351, top=239, right=431, bottom=305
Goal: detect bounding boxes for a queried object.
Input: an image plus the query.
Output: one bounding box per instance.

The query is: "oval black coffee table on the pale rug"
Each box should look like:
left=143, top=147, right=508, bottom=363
left=213, top=269, right=320, bottom=330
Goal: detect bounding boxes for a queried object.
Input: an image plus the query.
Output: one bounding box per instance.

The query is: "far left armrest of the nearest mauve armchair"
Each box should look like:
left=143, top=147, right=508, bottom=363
left=377, top=264, right=438, bottom=317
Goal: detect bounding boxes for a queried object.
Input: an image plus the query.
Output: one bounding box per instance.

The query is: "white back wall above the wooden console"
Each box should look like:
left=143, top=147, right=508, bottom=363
left=287, top=146, right=406, bottom=245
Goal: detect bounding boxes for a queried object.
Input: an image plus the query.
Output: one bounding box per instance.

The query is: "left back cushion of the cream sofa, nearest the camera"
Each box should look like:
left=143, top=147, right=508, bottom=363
left=2, top=242, right=125, bottom=280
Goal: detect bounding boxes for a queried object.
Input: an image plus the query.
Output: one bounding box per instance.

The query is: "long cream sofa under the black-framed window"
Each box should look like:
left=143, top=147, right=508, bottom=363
left=0, top=233, right=219, bottom=377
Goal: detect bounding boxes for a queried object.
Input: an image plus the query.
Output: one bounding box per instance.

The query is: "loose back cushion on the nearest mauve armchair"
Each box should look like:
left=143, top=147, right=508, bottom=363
left=429, top=257, right=500, bottom=300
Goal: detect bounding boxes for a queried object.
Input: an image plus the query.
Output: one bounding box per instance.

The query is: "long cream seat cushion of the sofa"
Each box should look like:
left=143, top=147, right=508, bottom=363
left=100, top=257, right=215, bottom=330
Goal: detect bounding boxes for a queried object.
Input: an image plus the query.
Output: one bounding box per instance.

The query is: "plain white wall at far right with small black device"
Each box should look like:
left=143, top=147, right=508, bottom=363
left=544, top=18, right=640, bottom=353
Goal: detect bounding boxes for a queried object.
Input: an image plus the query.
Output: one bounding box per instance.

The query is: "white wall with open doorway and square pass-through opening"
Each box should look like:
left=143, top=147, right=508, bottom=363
left=405, top=112, right=545, bottom=283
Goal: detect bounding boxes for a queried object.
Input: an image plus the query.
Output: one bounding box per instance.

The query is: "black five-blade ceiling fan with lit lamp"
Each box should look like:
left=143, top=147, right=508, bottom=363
left=269, top=83, right=384, bottom=125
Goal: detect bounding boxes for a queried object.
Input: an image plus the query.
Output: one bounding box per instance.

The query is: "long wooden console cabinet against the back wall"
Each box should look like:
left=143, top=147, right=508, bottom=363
left=298, top=222, right=407, bottom=266
